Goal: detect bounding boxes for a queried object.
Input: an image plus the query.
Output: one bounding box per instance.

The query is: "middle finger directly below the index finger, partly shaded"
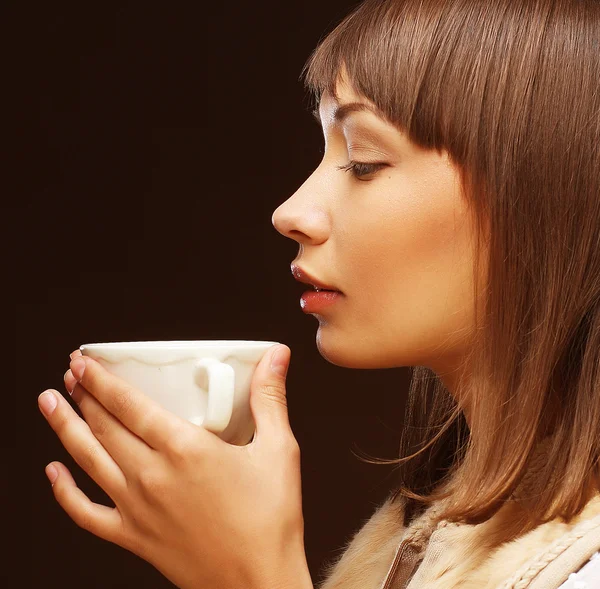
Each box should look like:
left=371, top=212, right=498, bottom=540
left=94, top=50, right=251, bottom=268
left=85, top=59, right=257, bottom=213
left=64, top=370, right=153, bottom=480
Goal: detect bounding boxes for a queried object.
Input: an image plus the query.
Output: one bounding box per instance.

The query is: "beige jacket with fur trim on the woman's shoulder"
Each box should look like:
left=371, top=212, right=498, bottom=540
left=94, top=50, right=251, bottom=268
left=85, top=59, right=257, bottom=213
left=317, top=440, right=600, bottom=589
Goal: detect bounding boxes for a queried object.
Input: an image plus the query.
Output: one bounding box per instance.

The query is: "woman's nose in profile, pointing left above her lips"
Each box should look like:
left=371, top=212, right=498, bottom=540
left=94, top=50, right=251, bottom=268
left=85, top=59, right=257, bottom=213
left=271, top=173, right=329, bottom=245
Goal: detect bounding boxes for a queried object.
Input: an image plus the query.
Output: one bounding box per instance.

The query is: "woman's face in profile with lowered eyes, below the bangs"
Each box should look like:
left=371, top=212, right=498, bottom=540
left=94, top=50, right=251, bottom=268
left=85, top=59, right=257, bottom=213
left=272, top=74, right=482, bottom=374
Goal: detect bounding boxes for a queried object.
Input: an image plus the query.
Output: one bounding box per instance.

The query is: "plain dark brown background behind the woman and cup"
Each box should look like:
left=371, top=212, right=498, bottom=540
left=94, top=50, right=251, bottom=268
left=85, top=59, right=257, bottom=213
left=12, top=0, right=408, bottom=588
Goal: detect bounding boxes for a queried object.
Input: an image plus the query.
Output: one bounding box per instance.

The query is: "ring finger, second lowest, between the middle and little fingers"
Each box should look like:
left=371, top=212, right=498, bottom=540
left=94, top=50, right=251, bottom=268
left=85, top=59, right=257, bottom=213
left=38, top=389, right=127, bottom=502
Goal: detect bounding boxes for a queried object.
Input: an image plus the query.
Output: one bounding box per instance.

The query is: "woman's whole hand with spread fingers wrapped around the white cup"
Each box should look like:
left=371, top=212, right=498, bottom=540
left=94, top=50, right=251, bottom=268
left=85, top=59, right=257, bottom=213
left=39, top=346, right=312, bottom=589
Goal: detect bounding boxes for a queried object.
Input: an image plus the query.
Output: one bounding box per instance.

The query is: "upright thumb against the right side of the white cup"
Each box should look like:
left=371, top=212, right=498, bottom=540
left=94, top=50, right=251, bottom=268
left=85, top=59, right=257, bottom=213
left=250, top=344, right=292, bottom=440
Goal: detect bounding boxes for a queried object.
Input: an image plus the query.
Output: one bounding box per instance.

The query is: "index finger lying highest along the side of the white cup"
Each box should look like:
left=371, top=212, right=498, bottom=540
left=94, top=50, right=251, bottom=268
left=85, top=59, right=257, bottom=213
left=71, top=356, right=193, bottom=450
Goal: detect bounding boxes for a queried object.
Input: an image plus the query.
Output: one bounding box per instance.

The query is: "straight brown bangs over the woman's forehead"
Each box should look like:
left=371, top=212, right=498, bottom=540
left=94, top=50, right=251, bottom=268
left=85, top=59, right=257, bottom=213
left=303, top=0, right=482, bottom=153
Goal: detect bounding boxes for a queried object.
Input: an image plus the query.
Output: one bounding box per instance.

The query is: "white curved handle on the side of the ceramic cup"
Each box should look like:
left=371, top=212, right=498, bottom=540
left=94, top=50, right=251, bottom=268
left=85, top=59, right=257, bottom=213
left=196, top=358, right=235, bottom=433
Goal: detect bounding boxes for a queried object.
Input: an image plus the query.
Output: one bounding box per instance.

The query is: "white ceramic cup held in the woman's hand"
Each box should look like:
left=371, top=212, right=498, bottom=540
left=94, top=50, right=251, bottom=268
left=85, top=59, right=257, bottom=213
left=79, top=340, right=279, bottom=445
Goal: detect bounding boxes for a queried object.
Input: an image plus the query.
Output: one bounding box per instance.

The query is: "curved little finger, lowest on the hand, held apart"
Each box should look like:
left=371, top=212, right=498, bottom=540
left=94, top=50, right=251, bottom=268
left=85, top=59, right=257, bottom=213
left=46, top=462, right=124, bottom=545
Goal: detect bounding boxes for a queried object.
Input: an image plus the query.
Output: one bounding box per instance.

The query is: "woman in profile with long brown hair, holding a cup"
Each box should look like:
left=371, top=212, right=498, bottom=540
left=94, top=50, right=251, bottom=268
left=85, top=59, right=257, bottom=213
left=37, top=0, right=600, bottom=589
